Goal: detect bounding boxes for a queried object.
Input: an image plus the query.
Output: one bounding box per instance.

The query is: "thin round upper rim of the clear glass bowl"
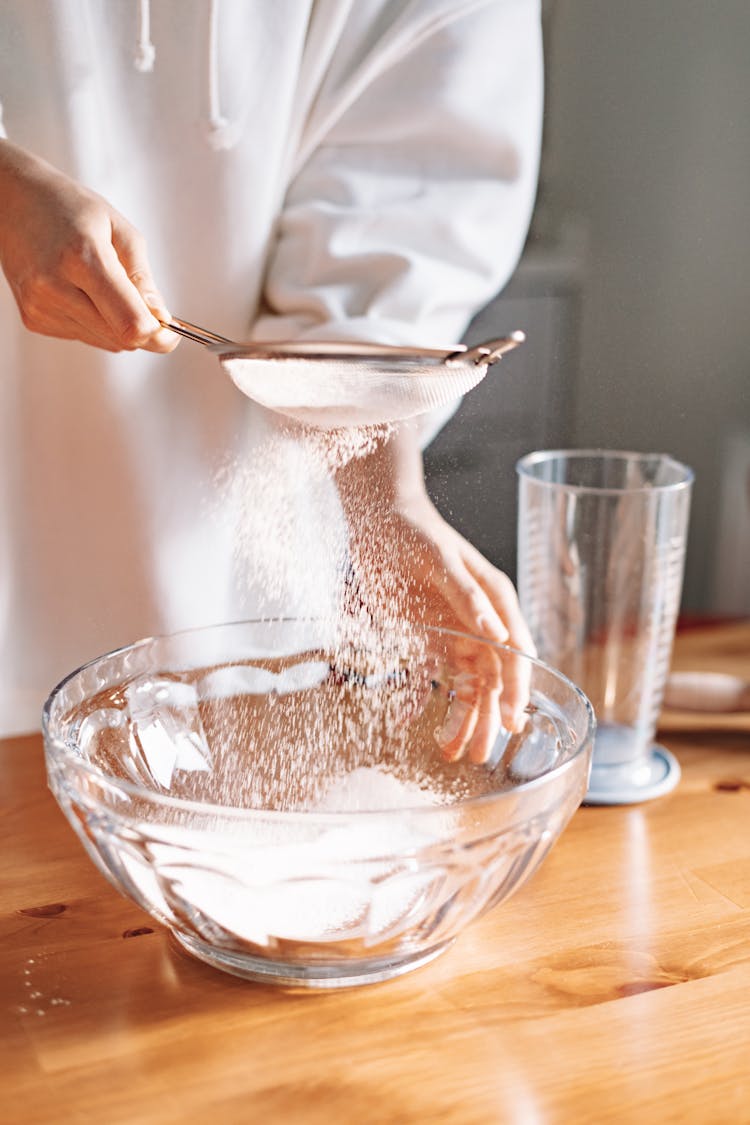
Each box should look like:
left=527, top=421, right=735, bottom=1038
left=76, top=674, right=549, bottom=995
left=42, top=617, right=596, bottom=825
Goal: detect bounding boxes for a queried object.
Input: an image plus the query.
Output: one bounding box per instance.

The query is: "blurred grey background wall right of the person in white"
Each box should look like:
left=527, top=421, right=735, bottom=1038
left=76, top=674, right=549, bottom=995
left=427, top=0, right=750, bottom=612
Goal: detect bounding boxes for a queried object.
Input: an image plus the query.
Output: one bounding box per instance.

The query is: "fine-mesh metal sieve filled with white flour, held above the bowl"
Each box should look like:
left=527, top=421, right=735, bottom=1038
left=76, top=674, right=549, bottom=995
left=163, top=318, right=525, bottom=430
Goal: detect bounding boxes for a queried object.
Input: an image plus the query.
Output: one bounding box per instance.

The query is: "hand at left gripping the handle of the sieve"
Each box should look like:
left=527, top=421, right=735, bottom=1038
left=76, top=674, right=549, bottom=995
left=0, top=141, right=179, bottom=352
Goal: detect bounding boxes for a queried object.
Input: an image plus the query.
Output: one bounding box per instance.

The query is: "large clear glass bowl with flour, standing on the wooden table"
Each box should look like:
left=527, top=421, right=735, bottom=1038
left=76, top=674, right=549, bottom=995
left=44, top=620, right=595, bottom=988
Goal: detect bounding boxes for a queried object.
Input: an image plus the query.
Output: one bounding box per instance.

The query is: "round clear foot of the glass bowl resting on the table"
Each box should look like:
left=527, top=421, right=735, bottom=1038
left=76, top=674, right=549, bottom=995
left=171, top=930, right=455, bottom=989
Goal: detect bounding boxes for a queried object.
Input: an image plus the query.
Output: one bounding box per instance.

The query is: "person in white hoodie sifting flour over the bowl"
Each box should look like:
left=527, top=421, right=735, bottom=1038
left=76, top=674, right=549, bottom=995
left=0, top=0, right=542, bottom=735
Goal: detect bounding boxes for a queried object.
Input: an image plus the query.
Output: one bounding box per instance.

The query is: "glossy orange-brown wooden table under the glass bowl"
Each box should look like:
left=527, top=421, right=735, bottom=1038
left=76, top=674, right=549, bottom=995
left=0, top=624, right=750, bottom=1125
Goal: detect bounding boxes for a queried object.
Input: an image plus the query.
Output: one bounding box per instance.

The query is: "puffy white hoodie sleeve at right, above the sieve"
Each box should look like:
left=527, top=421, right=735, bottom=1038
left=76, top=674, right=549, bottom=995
left=253, top=0, right=543, bottom=434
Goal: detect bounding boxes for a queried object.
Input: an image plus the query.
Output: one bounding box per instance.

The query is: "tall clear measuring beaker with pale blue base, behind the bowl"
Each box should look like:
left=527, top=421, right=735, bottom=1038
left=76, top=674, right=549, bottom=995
left=516, top=450, right=693, bottom=804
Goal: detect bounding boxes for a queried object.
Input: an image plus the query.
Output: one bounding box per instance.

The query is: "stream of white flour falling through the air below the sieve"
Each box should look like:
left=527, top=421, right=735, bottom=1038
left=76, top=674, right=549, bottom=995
left=201, top=414, right=443, bottom=811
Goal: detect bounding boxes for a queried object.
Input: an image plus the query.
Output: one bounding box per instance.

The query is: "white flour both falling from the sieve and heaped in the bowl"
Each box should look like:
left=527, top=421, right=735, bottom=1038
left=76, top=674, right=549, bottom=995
left=117, top=409, right=474, bottom=947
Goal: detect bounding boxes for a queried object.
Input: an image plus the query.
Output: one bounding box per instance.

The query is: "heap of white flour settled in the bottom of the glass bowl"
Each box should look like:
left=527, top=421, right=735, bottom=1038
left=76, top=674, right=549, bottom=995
left=128, top=766, right=453, bottom=946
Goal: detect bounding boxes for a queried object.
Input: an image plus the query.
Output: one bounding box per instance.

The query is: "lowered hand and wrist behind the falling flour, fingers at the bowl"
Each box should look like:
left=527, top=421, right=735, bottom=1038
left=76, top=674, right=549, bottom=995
left=332, top=427, right=534, bottom=762
